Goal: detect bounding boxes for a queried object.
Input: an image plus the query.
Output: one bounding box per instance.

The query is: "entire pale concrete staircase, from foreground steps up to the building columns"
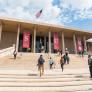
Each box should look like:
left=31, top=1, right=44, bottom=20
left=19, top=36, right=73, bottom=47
left=0, top=53, right=92, bottom=92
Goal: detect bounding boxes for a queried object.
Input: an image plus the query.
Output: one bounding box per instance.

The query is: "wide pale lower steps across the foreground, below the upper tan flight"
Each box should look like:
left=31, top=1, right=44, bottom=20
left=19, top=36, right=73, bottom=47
left=0, top=68, right=92, bottom=92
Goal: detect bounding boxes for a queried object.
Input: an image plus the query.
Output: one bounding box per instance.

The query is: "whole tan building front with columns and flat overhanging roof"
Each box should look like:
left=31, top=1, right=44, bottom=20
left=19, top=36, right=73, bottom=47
left=0, top=18, right=92, bottom=53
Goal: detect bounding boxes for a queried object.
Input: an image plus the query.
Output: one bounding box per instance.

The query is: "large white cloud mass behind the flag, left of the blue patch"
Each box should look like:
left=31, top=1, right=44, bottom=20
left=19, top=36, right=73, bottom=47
left=0, top=0, right=60, bottom=23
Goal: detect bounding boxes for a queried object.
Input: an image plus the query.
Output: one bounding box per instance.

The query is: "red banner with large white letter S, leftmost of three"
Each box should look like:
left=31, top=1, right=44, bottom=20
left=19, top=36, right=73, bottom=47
left=23, top=32, right=30, bottom=48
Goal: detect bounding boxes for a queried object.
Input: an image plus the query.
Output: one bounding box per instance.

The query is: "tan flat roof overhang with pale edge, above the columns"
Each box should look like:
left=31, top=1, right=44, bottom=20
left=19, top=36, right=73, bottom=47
left=0, top=18, right=92, bottom=36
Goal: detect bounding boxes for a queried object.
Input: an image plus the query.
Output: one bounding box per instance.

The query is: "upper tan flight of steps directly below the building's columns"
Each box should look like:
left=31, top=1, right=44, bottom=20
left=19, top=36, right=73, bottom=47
left=0, top=53, right=88, bottom=70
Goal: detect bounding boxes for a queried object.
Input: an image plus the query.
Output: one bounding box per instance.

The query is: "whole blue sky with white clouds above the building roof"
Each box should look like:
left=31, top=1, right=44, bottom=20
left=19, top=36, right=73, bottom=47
left=0, top=0, right=92, bottom=31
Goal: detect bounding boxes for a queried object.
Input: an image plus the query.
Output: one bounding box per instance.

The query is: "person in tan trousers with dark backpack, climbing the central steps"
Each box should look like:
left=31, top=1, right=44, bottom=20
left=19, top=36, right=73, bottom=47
left=38, top=55, right=45, bottom=77
